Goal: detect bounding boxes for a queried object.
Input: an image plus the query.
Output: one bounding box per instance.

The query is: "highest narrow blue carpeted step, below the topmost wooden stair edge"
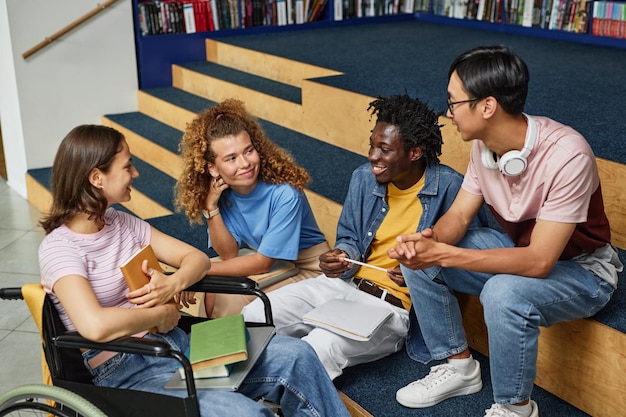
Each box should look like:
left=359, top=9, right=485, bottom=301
left=176, top=61, right=302, bottom=104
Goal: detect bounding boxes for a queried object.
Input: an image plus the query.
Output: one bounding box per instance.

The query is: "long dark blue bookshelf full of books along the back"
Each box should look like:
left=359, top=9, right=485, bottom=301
left=132, top=0, right=626, bottom=88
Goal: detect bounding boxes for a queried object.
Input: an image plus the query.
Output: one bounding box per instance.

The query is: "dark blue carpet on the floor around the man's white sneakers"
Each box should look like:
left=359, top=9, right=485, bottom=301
left=335, top=350, right=588, bottom=417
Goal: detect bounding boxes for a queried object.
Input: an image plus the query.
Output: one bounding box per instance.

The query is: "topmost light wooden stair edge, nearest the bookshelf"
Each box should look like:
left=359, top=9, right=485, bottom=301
left=205, top=39, right=343, bottom=87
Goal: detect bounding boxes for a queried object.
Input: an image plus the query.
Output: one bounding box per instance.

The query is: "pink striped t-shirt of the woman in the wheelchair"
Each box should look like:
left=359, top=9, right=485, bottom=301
left=39, top=208, right=152, bottom=330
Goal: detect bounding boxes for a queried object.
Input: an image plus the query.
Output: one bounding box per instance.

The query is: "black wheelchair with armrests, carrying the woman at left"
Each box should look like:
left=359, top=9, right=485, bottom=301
left=0, top=276, right=274, bottom=417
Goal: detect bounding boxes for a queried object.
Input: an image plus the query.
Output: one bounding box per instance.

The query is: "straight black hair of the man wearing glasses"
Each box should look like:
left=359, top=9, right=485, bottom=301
left=448, top=45, right=530, bottom=115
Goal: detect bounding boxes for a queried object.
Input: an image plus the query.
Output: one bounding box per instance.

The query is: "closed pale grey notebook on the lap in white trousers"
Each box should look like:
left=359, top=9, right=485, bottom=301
left=303, top=298, right=392, bottom=341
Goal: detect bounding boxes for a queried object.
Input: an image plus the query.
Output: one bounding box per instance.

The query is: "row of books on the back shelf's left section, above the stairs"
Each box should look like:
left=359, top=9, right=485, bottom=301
left=138, top=0, right=328, bottom=36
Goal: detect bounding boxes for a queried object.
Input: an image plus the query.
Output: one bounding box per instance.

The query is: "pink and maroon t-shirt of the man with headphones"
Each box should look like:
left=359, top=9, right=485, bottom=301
left=462, top=116, right=611, bottom=259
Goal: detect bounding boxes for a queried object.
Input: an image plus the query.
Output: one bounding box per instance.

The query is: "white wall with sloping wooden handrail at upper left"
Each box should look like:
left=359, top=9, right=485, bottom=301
left=0, top=0, right=138, bottom=197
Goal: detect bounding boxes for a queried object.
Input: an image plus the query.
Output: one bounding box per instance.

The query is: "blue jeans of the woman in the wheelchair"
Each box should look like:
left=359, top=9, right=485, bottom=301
left=84, top=328, right=349, bottom=417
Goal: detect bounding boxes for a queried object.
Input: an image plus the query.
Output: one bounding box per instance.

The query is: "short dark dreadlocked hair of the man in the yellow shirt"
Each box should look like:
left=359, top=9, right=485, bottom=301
left=367, top=94, right=443, bottom=164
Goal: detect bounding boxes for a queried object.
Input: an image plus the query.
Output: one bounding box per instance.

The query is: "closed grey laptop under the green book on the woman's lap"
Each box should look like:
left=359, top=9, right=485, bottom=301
left=165, top=326, right=276, bottom=391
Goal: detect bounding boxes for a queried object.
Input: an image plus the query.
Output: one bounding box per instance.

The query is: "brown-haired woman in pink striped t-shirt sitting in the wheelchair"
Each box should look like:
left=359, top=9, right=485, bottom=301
left=39, top=125, right=349, bottom=417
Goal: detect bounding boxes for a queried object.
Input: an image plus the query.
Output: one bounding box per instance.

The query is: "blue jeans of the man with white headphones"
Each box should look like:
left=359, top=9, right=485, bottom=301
left=402, top=228, right=614, bottom=404
